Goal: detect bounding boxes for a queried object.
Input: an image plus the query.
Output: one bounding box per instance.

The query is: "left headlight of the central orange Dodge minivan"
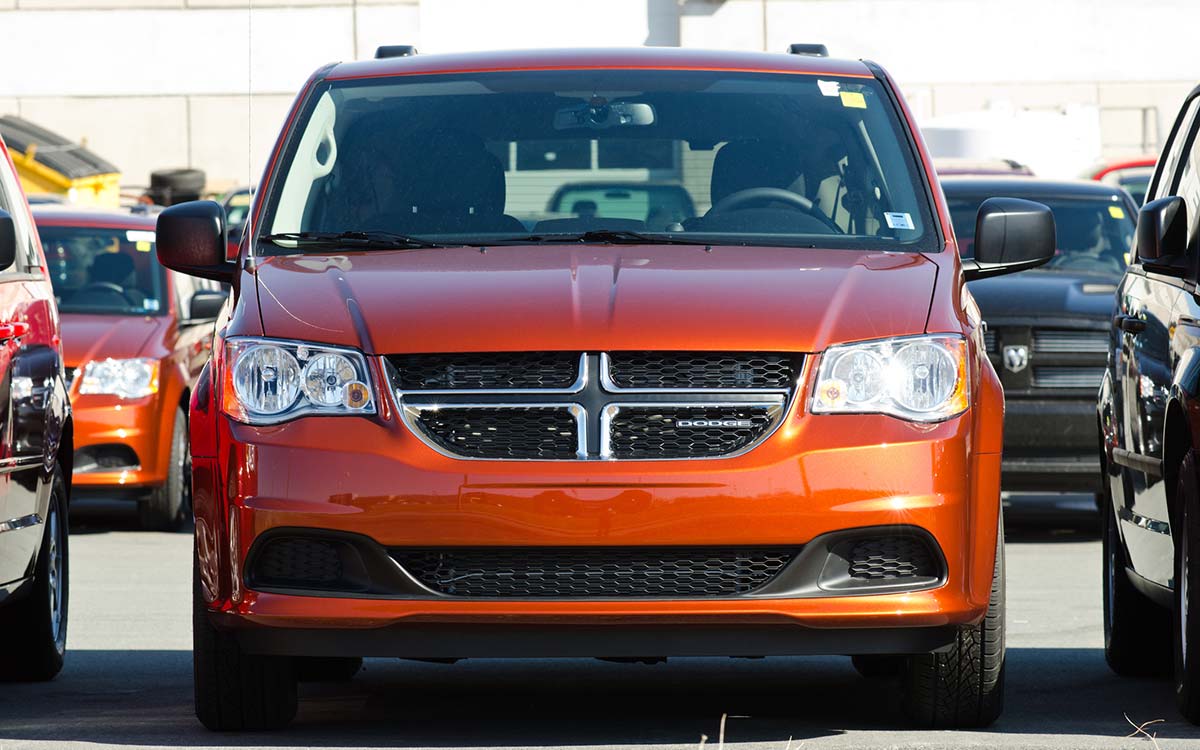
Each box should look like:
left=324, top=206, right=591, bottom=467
left=222, top=338, right=376, bottom=425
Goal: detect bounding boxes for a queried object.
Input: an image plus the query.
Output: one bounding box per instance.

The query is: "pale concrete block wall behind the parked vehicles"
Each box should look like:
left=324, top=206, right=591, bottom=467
left=0, top=0, right=1200, bottom=187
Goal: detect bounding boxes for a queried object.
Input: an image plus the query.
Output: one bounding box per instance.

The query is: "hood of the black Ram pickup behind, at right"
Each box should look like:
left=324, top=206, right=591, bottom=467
left=967, top=270, right=1121, bottom=320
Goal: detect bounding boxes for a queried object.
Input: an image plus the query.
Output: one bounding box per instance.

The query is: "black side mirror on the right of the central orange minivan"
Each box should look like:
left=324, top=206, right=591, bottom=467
left=962, top=198, right=1055, bottom=281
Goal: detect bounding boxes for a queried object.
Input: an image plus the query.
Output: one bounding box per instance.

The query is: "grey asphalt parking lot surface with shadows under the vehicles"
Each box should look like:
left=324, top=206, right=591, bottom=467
left=0, top=496, right=1200, bottom=750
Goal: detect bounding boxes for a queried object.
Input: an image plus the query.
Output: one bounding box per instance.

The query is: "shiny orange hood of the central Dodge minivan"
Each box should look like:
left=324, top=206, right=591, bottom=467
left=256, top=245, right=937, bottom=354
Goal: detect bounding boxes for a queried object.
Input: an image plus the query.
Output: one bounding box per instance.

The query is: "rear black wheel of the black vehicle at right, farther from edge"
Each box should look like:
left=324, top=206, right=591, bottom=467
left=1100, top=480, right=1171, bottom=677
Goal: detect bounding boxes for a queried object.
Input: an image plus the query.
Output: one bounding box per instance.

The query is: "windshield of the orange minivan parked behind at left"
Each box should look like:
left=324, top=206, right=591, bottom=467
left=38, top=226, right=167, bottom=316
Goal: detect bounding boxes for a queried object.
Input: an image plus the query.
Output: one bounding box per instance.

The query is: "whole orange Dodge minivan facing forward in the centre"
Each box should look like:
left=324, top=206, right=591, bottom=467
left=157, top=49, right=1054, bottom=730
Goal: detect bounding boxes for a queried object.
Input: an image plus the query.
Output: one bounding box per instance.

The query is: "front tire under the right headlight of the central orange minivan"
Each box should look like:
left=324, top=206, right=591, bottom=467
left=905, top=520, right=1004, bottom=728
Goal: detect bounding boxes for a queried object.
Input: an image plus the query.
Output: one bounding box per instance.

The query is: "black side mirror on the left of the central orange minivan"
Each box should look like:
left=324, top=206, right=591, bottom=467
left=157, top=200, right=238, bottom=283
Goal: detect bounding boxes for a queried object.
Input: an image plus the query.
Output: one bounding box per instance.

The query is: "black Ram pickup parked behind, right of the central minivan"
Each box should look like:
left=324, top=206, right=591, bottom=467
left=942, top=178, right=1138, bottom=493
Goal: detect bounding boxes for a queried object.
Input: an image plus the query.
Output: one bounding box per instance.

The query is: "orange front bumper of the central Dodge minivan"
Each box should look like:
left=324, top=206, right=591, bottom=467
left=193, top=384, right=1000, bottom=658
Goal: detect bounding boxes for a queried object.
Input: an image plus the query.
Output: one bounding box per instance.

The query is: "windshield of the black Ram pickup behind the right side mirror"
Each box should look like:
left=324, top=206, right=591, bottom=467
left=947, top=194, right=1136, bottom=276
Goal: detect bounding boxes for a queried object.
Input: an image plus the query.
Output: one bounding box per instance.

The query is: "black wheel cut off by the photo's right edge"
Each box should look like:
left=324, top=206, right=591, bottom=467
left=1171, top=450, right=1200, bottom=724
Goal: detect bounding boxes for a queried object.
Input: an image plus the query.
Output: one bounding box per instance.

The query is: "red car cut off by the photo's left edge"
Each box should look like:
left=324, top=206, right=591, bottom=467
left=0, top=133, right=73, bottom=680
